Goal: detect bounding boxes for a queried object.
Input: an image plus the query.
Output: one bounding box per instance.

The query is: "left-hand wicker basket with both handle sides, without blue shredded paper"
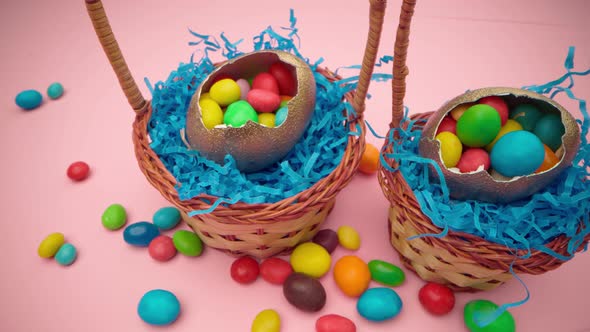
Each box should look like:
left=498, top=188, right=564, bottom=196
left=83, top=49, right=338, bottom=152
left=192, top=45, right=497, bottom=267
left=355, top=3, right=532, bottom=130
left=86, top=0, right=386, bottom=258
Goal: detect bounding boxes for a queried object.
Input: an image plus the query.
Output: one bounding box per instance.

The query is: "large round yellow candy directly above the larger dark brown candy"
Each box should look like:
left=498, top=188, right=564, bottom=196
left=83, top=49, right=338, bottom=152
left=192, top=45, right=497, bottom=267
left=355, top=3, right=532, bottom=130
left=291, top=242, right=332, bottom=278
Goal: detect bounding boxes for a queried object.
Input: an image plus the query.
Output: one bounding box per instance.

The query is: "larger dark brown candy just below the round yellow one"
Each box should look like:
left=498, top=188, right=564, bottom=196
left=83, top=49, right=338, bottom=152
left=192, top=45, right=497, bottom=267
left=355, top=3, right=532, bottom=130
left=283, top=273, right=326, bottom=312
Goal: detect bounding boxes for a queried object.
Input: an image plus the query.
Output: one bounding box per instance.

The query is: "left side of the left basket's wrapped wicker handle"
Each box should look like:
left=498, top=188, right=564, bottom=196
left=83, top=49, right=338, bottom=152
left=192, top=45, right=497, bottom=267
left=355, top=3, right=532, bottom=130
left=86, top=0, right=147, bottom=113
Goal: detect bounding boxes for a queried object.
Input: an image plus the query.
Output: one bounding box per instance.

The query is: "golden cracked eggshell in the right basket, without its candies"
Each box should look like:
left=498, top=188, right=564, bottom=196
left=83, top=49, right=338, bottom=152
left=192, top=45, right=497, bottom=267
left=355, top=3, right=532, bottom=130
left=419, top=87, right=580, bottom=203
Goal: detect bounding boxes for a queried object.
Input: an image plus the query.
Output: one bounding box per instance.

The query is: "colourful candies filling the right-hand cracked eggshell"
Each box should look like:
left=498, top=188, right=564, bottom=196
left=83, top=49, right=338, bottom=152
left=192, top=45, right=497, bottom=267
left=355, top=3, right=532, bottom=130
left=436, top=96, right=565, bottom=180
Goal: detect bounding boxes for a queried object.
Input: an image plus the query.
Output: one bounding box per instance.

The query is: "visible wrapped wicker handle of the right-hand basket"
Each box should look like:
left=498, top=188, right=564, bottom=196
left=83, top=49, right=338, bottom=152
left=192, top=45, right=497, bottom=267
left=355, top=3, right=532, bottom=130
left=389, top=0, right=417, bottom=128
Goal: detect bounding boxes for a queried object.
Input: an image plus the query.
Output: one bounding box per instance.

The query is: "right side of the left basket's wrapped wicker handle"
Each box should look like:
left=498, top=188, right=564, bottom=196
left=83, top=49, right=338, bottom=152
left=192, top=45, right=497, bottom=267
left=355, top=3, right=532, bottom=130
left=353, top=0, right=387, bottom=115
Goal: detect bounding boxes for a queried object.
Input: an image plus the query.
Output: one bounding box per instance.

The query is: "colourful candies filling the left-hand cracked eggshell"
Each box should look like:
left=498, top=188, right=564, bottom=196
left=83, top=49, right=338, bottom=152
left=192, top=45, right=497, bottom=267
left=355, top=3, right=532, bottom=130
left=199, top=62, right=297, bottom=129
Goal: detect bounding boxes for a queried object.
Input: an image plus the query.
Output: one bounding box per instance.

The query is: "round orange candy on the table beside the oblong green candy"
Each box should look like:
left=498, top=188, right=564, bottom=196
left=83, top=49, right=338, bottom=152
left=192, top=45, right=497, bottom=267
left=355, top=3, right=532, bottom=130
left=334, top=256, right=371, bottom=297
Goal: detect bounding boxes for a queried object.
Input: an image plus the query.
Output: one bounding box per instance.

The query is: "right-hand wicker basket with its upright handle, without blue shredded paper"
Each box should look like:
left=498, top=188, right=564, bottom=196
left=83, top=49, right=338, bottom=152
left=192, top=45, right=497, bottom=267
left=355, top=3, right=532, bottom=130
left=378, top=0, right=590, bottom=291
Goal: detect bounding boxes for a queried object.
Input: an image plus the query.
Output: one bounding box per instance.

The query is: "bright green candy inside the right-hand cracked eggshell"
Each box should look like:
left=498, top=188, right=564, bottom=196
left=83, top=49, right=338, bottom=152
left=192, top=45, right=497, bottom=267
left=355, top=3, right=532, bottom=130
left=457, top=104, right=502, bottom=148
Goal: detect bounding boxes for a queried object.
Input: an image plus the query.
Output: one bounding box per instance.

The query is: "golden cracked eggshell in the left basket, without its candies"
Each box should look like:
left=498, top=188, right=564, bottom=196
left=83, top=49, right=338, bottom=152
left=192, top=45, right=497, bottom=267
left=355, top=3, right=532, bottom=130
left=186, top=50, right=316, bottom=172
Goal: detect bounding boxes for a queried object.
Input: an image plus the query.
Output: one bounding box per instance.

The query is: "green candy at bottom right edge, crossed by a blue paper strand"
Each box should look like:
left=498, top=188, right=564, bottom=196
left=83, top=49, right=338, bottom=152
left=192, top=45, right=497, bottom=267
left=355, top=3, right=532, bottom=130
left=463, top=300, right=516, bottom=332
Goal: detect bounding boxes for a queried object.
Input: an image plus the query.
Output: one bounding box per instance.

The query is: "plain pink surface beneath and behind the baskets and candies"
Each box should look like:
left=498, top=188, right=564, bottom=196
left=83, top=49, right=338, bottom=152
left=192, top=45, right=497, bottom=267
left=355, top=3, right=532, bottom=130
left=0, top=0, right=590, bottom=332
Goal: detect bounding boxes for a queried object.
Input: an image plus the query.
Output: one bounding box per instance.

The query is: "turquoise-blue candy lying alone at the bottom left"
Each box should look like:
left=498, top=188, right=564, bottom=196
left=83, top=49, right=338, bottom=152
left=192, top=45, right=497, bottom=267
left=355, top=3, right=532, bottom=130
left=137, top=289, right=180, bottom=326
